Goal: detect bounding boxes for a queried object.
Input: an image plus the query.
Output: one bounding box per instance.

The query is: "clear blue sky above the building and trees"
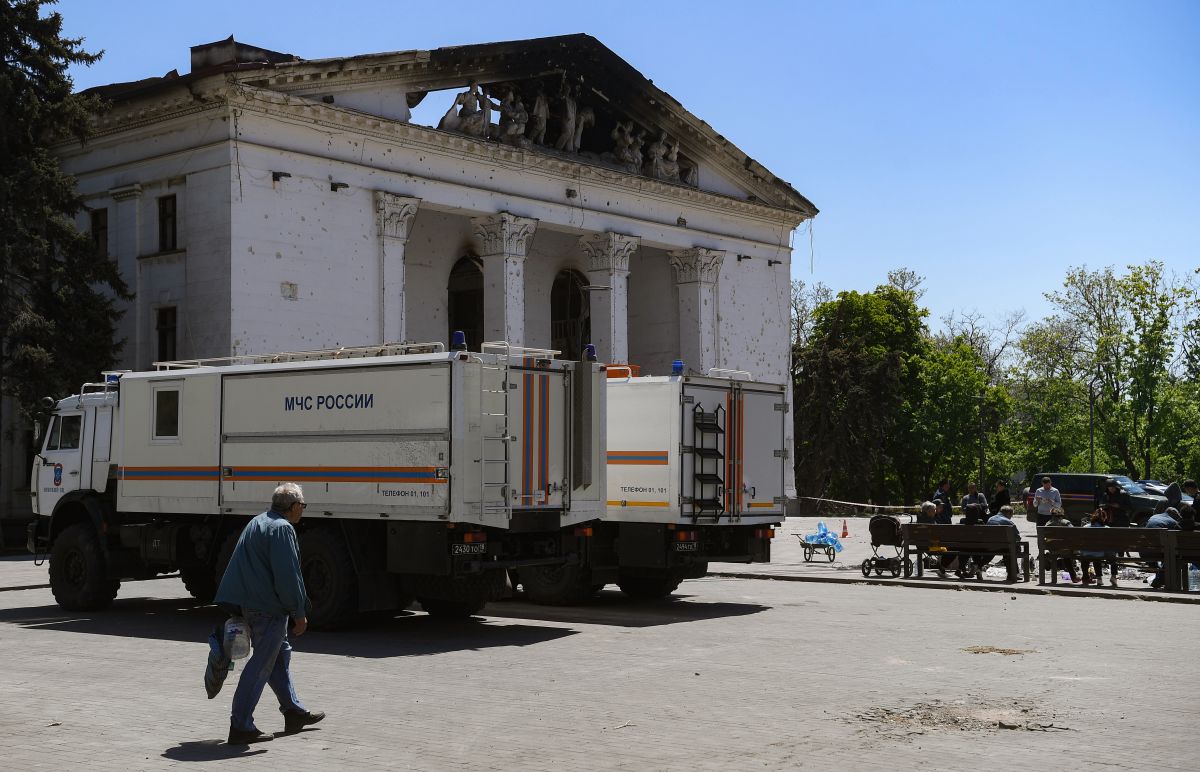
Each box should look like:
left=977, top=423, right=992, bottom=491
left=58, top=0, right=1200, bottom=328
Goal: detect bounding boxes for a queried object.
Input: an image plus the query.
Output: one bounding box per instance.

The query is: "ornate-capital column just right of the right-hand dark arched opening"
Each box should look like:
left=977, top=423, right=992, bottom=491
left=580, top=233, right=640, bottom=364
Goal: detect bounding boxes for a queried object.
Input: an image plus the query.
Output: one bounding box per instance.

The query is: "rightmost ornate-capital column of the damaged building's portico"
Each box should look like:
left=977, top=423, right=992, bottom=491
left=668, top=247, right=725, bottom=375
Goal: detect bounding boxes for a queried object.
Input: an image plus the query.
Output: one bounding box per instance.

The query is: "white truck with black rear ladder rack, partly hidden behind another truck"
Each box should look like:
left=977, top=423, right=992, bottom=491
left=520, top=363, right=788, bottom=604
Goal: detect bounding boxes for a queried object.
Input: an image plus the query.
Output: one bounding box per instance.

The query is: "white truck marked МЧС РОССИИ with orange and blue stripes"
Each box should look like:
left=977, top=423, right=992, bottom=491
left=29, top=343, right=606, bottom=627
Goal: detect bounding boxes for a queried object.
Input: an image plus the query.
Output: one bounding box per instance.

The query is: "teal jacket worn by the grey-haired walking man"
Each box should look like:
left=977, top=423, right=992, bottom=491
left=216, top=510, right=311, bottom=620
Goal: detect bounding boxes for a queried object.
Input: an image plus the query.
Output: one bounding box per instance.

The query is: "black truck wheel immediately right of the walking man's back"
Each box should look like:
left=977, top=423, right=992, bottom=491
left=300, top=528, right=359, bottom=630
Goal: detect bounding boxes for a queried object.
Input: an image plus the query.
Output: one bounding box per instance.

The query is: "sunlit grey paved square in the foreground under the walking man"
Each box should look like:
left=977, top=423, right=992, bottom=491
left=0, top=561, right=1200, bottom=772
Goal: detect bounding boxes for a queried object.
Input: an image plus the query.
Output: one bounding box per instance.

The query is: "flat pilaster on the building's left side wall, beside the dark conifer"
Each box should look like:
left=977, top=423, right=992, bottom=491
left=108, top=182, right=142, bottom=370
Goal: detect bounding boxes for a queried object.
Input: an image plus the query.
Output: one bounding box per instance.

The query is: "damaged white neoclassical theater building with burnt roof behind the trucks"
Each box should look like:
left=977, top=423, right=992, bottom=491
left=5, top=35, right=817, bottom=525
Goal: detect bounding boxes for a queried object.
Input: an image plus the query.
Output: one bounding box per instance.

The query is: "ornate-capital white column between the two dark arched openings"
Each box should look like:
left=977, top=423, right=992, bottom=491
left=470, top=211, right=538, bottom=346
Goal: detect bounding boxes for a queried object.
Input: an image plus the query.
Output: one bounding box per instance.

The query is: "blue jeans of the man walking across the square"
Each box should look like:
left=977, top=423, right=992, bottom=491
left=229, top=610, right=305, bottom=731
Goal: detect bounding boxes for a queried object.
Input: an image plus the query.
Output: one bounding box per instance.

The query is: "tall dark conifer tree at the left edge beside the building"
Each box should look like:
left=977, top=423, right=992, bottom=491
left=0, top=0, right=128, bottom=422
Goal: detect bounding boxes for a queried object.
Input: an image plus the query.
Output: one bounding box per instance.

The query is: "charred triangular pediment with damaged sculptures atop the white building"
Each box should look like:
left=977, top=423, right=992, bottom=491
left=226, top=35, right=817, bottom=220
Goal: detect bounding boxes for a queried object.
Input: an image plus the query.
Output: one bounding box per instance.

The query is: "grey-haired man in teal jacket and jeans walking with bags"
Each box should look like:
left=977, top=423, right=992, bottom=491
left=216, top=483, right=325, bottom=746
